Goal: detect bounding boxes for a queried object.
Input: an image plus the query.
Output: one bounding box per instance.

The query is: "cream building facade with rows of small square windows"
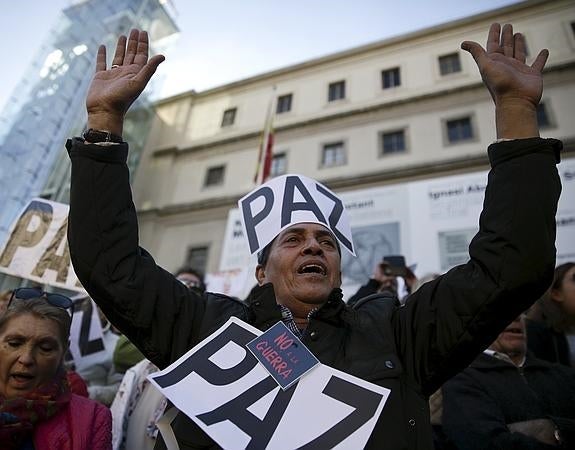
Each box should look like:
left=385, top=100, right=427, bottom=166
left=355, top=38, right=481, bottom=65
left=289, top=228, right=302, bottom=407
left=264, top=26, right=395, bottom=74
left=134, top=0, right=575, bottom=298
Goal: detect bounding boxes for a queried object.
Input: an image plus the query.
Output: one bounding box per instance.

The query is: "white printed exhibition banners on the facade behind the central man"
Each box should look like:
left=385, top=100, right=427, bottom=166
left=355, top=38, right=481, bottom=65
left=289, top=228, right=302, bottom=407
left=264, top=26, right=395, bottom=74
left=217, top=158, right=575, bottom=296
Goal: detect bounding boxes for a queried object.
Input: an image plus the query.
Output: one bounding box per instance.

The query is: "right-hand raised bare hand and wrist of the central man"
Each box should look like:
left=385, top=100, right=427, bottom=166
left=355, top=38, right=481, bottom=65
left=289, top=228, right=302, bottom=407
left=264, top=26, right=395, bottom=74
left=461, top=23, right=549, bottom=138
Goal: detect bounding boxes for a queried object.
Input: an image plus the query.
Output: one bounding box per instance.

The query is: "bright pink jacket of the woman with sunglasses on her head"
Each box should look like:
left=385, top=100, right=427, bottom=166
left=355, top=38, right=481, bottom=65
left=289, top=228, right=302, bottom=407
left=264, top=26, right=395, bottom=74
left=34, top=394, right=112, bottom=450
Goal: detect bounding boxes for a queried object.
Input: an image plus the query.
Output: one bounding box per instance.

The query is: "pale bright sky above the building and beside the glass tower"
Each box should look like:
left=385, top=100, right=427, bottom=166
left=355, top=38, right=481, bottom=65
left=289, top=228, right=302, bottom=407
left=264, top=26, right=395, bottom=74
left=0, top=0, right=517, bottom=109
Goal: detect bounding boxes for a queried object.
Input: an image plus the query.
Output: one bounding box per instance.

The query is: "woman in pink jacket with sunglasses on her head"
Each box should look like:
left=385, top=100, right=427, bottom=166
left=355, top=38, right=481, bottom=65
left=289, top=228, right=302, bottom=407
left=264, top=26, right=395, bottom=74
left=0, top=288, right=112, bottom=450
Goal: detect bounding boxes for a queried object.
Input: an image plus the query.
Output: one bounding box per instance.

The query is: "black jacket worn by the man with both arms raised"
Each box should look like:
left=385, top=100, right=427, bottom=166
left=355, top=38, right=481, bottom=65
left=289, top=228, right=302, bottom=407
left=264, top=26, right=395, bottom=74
left=68, top=138, right=561, bottom=449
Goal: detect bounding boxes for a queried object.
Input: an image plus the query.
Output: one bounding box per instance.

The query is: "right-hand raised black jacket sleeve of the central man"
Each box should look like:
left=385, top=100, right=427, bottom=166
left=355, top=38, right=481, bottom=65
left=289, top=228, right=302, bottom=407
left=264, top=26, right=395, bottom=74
left=392, top=138, right=562, bottom=395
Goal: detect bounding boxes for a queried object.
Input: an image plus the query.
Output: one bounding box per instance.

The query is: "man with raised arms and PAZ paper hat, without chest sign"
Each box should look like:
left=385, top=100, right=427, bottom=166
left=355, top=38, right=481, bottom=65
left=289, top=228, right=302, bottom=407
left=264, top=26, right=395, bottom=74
left=67, top=24, right=562, bottom=449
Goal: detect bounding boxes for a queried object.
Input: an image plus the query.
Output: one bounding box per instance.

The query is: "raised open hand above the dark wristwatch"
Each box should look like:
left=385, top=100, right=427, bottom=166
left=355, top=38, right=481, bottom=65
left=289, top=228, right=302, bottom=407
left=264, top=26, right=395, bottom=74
left=86, top=29, right=164, bottom=135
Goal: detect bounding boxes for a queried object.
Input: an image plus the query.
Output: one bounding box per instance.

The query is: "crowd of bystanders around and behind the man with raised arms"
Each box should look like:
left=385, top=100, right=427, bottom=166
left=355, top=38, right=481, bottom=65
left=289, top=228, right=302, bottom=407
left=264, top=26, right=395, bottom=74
left=0, top=255, right=575, bottom=450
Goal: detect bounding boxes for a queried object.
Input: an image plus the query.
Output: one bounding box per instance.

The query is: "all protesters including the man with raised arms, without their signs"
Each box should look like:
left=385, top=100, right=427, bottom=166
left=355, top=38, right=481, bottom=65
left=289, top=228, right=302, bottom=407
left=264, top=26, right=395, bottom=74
left=0, top=24, right=575, bottom=450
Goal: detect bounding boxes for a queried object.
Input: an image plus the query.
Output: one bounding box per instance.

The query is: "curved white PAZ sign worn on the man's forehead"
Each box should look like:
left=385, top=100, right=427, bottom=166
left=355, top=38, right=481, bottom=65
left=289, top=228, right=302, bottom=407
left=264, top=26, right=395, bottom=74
left=238, top=175, right=355, bottom=255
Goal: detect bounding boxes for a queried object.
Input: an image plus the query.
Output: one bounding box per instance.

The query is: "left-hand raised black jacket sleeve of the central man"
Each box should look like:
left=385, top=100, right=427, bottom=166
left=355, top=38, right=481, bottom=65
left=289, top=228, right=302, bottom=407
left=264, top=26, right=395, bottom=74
left=67, top=139, right=206, bottom=368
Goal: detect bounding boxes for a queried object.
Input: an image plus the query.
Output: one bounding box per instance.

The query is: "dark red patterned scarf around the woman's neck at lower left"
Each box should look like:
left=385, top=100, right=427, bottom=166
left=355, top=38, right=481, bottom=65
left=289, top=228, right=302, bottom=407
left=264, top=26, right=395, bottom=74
left=0, top=369, right=71, bottom=450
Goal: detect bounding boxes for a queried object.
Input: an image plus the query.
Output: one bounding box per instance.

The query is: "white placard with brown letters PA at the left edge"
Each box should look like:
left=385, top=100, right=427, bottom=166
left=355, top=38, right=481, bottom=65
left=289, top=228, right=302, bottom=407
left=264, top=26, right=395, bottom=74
left=0, top=198, right=83, bottom=292
